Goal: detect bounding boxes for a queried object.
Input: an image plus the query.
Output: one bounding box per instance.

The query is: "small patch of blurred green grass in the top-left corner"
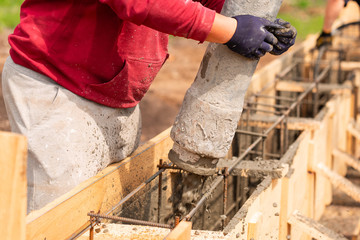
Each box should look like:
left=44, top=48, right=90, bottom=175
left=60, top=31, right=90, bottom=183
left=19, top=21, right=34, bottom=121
left=0, top=0, right=23, bottom=30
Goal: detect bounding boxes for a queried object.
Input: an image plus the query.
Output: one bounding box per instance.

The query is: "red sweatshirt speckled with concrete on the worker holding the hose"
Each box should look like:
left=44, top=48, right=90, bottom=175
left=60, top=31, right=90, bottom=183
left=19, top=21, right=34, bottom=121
left=9, top=0, right=224, bottom=108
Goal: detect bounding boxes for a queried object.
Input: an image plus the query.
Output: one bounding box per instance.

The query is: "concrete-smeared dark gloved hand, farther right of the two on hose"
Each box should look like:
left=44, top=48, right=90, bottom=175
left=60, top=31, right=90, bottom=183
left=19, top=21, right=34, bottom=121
left=269, top=18, right=297, bottom=55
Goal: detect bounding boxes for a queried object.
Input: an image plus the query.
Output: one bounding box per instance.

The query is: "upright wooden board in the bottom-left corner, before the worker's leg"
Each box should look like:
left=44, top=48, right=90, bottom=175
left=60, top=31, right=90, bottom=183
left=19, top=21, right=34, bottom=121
left=0, top=132, right=27, bottom=240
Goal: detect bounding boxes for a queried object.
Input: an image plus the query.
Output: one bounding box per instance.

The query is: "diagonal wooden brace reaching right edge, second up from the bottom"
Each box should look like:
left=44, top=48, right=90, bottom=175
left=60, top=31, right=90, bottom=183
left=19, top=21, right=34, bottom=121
left=317, top=163, right=360, bottom=202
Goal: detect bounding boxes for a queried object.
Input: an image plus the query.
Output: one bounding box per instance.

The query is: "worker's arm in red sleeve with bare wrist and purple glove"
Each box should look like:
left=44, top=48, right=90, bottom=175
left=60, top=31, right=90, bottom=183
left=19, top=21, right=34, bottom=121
left=100, top=0, right=296, bottom=58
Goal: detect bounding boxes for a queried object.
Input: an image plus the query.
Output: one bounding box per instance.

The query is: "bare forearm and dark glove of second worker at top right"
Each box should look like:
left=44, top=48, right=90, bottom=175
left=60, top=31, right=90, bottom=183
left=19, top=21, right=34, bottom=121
left=316, top=0, right=360, bottom=48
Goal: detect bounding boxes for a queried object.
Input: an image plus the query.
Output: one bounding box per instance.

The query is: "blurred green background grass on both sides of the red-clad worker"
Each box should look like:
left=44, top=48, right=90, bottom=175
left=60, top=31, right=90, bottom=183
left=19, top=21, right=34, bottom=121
left=0, top=0, right=326, bottom=41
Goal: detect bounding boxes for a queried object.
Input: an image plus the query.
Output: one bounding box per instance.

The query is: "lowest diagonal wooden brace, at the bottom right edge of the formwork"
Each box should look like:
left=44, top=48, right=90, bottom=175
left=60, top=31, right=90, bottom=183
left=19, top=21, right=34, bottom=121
left=289, top=211, right=347, bottom=240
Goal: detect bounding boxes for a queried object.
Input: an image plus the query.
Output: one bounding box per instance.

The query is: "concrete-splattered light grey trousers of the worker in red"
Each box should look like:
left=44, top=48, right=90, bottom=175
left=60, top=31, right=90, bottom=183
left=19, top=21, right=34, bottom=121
left=2, top=57, right=141, bottom=212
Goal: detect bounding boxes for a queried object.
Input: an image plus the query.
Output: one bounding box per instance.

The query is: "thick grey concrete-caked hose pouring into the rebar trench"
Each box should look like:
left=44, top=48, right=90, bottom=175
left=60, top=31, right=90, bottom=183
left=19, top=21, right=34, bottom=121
left=169, top=0, right=282, bottom=175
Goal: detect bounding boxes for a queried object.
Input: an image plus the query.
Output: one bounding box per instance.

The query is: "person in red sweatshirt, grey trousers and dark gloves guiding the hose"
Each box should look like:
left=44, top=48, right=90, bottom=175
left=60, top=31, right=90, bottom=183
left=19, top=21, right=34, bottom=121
left=2, top=0, right=296, bottom=212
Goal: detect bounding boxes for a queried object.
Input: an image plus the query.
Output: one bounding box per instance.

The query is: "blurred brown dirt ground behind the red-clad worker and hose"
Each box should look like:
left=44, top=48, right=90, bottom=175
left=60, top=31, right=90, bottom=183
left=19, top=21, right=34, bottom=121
left=0, top=30, right=275, bottom=143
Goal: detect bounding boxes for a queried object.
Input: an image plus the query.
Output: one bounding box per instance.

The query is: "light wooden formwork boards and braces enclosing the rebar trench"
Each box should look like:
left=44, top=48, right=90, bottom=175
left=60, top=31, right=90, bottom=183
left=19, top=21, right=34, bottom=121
left=0, top=4, right=360, bottom=240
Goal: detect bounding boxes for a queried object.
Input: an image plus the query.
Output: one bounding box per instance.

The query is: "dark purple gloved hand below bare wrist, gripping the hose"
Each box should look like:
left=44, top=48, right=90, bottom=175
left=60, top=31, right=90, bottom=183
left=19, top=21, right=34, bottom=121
left=225, top=15, right=284, bottom=59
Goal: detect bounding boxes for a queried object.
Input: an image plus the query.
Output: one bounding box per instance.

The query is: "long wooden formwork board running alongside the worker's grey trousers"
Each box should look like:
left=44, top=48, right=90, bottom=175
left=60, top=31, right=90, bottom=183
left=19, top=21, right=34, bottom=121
left=26, top=128, right=173, bottom=240
